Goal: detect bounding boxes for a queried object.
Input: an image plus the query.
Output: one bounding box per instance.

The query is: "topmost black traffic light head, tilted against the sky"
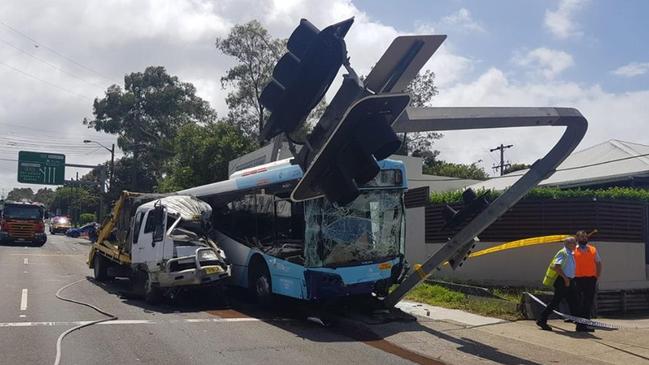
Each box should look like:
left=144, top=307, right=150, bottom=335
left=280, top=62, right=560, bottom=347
left=259, top=18, right=354, bottom=140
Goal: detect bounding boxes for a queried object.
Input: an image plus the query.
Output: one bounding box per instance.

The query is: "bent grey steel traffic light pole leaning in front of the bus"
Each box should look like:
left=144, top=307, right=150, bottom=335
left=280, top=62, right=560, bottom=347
left=383, top=107, right=588, bottom=307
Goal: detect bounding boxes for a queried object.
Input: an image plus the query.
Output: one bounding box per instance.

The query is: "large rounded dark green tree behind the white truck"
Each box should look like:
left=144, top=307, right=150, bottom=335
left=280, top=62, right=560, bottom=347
left=83, top=66, right=216, bottom=178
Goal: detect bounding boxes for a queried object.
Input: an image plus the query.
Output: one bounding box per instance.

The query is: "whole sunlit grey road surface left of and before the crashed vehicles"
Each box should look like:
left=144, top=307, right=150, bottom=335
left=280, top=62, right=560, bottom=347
left=0, top=236, right=416, bottom=363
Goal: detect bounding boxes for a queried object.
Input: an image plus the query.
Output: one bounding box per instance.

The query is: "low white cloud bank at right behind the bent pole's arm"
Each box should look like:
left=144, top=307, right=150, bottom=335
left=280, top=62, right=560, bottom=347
left=433, top=68, right=649, bottom=176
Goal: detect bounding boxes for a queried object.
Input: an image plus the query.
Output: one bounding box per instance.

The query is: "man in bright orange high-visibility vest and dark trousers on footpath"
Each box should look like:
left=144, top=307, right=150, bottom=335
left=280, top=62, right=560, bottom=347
left=575, top=231, right=602, bottom=332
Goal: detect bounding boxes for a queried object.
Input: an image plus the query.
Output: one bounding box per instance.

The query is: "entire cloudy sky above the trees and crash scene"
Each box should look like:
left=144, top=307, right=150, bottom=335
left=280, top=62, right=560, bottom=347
left=0, top=0, right=649, bottom=192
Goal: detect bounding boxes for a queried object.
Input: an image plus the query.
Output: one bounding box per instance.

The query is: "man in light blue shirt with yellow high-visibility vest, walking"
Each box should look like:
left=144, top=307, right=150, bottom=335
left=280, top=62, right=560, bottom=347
left=536, top=237, right=577, bottom=331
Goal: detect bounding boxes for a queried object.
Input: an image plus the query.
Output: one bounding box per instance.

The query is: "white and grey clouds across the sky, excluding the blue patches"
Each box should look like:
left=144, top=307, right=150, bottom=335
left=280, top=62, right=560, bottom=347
left=0, top=0, right=649, bottom=189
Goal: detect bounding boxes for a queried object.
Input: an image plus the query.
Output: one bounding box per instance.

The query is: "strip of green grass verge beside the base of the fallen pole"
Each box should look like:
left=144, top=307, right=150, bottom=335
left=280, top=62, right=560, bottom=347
left=405, top=282, right=522, bottom=321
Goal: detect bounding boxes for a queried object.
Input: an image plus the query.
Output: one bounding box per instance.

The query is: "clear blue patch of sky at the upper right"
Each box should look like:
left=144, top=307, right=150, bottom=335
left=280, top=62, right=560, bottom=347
left=354, top=0, right=649, bottom=92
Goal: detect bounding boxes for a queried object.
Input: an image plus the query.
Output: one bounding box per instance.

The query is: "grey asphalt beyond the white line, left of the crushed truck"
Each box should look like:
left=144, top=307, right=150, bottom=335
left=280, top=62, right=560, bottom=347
left=0, top=236, right=223, bottom=322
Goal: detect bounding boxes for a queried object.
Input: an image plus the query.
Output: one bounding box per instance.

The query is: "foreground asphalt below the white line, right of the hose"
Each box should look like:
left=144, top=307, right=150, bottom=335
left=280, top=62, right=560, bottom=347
left=54, top=318, right=410, bottom=365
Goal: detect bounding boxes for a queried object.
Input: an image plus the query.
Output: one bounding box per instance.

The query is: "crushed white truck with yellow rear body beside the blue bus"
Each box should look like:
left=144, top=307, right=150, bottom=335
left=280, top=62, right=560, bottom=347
left=88, top=191, right=231, bottom=303
